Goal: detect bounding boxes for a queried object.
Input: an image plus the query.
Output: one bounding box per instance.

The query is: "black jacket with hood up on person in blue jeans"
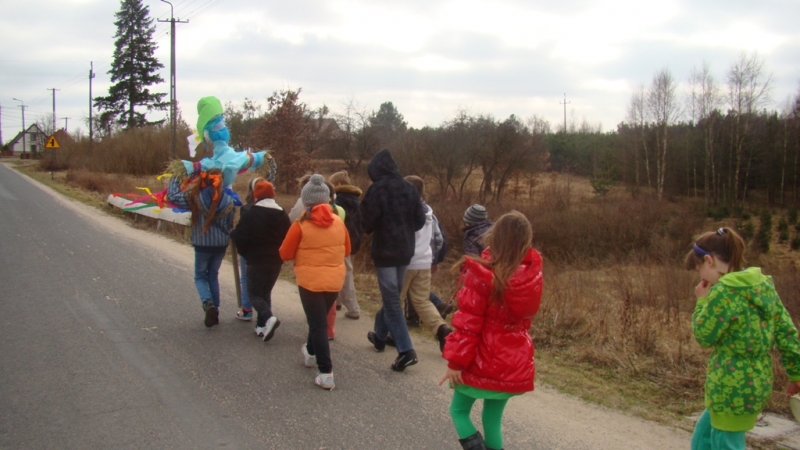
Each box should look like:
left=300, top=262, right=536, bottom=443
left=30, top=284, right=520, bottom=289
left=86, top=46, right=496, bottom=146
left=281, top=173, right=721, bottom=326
left=361, top=149, right=425, bottom=267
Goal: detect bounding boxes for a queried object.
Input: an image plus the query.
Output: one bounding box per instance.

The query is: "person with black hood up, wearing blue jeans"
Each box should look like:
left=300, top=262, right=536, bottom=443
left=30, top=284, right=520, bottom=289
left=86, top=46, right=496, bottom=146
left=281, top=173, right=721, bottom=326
left=361, top=149, right=426, bottom=372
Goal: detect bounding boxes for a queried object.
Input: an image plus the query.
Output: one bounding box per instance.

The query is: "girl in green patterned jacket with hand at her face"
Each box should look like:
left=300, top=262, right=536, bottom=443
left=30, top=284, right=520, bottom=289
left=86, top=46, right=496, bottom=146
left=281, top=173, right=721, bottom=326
left=684, top=228, right=800, bottom=450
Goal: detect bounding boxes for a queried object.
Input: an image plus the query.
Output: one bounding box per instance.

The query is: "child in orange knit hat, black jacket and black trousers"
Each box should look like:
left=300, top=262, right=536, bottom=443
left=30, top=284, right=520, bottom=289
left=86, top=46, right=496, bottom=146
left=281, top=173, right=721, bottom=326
left=231, top=179, right=291, bottom=342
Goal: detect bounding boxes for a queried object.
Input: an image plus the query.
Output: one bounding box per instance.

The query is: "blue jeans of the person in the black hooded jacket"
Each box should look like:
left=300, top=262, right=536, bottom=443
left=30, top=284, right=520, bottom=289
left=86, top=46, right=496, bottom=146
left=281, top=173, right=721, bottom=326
left=375, top=266, right=414, bottom=353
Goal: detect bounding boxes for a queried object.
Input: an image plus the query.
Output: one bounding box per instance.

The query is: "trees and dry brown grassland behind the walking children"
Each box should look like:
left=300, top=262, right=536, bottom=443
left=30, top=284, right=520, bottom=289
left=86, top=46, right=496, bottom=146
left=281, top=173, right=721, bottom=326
left=10, top=54, right=800, bottom=438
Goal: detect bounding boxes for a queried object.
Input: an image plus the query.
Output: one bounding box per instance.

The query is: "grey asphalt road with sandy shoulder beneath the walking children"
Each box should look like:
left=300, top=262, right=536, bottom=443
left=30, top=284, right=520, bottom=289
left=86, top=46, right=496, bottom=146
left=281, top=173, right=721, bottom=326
left=0, top=164, right=688, bottom=449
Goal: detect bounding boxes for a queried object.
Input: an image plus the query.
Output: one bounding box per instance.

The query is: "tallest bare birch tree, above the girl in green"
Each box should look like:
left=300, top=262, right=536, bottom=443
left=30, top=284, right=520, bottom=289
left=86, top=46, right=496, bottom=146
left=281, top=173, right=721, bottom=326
left=728, top=53, right=772, bottom=204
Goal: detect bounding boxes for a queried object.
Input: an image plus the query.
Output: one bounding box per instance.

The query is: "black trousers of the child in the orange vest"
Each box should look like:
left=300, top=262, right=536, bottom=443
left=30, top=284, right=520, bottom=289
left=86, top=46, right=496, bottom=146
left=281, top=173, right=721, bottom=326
left=298, top=286, right=339, bottom=373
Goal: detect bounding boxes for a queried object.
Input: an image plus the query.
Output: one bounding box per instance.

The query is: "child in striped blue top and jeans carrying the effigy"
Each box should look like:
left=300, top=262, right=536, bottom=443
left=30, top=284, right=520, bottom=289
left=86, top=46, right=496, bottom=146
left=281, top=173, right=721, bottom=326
left=167, top=169, right=233, bottom=328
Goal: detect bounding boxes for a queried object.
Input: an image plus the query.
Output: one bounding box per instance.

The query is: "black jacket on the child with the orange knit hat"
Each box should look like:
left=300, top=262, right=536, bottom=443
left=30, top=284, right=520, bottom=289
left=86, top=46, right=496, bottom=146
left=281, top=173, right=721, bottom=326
left=231, top=199, right=292, bottom=265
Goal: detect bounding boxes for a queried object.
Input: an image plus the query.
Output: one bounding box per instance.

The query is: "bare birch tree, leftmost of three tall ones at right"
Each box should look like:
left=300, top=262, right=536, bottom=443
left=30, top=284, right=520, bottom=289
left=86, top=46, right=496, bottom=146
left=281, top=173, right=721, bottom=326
left=646, top=68, right=681, bottom=200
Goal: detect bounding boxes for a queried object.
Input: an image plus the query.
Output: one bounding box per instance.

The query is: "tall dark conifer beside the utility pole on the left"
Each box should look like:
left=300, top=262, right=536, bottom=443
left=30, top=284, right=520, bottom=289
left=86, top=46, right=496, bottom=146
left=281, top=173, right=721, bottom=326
left=94, top=0, right=168, bottom=128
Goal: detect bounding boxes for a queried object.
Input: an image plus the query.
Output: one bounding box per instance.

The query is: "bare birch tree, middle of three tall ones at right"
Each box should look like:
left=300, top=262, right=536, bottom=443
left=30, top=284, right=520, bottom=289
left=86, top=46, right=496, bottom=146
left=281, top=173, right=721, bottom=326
left=689, top=61, right=722, bottom=207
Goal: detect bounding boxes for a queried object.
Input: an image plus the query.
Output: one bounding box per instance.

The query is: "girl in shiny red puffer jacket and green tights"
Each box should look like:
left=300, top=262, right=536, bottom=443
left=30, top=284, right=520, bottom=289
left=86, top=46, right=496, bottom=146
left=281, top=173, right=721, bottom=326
left=439, top=211, right=542, bottom=450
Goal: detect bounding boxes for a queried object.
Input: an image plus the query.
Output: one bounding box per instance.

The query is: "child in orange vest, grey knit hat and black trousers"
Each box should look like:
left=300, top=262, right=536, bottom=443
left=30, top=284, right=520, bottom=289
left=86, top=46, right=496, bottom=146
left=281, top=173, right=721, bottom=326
left=280, top=174, right=350, bottom=389
